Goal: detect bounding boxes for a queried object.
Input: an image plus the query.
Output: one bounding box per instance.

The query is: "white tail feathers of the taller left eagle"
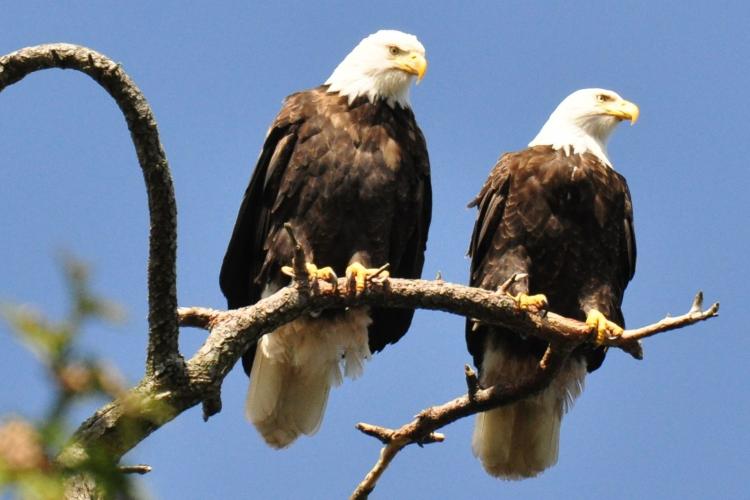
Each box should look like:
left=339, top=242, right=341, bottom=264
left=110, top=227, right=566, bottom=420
left=245, top=308, right=372, bottom=448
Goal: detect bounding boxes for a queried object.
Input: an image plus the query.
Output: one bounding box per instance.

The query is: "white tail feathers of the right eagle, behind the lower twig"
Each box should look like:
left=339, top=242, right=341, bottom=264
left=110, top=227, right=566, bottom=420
left=472, top=350, right=586, bottom=479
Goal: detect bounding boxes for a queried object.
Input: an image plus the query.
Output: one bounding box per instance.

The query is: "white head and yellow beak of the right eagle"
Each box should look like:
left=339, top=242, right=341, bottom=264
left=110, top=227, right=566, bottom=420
left=529, top=89, right=640, bottom=167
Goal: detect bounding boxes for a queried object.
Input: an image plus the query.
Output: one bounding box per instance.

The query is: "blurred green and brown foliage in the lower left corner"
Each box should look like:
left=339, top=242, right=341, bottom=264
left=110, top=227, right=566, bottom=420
left=0, top=256, right=143, bottom=499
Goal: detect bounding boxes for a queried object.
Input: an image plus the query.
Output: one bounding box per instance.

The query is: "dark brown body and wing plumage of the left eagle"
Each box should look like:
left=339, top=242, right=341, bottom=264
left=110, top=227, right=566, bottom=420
left=220, top=87, right=432, bottom=373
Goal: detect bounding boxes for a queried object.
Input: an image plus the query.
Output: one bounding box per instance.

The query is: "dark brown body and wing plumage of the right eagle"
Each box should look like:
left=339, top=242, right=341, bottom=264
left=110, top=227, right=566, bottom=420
left=466, top=146, right=636, bottom=371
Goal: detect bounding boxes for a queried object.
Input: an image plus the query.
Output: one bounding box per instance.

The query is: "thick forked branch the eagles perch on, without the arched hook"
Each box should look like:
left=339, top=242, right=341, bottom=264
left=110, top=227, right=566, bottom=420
left=57, top=278, right=718, bottom=478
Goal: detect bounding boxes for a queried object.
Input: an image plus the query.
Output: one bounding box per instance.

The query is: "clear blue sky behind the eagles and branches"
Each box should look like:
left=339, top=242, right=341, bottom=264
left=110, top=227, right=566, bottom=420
left=0, top=0, right=750, bottom=499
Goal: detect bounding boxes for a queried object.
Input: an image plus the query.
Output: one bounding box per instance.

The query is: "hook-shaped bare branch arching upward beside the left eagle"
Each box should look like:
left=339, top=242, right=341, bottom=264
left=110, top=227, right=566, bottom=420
left=0, top=43, right=182, bottom=376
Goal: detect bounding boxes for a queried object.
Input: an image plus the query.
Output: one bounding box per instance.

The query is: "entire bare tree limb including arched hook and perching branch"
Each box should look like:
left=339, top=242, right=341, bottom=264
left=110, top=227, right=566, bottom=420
left=0, top=44, right=718, bottom=498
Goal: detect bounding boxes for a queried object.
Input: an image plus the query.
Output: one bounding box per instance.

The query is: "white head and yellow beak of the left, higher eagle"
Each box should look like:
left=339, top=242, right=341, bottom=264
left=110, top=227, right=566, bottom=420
left=326, top=30, right=427, bottom=108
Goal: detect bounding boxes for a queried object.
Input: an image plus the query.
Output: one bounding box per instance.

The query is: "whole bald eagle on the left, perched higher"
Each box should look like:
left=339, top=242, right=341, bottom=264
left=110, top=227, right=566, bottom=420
left=220, top=30, right=432, bottom=448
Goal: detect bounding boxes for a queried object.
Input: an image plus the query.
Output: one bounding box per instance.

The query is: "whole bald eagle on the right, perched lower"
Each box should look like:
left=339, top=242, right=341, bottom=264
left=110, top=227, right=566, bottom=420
left=466, top=89, right=639, bottom=479
